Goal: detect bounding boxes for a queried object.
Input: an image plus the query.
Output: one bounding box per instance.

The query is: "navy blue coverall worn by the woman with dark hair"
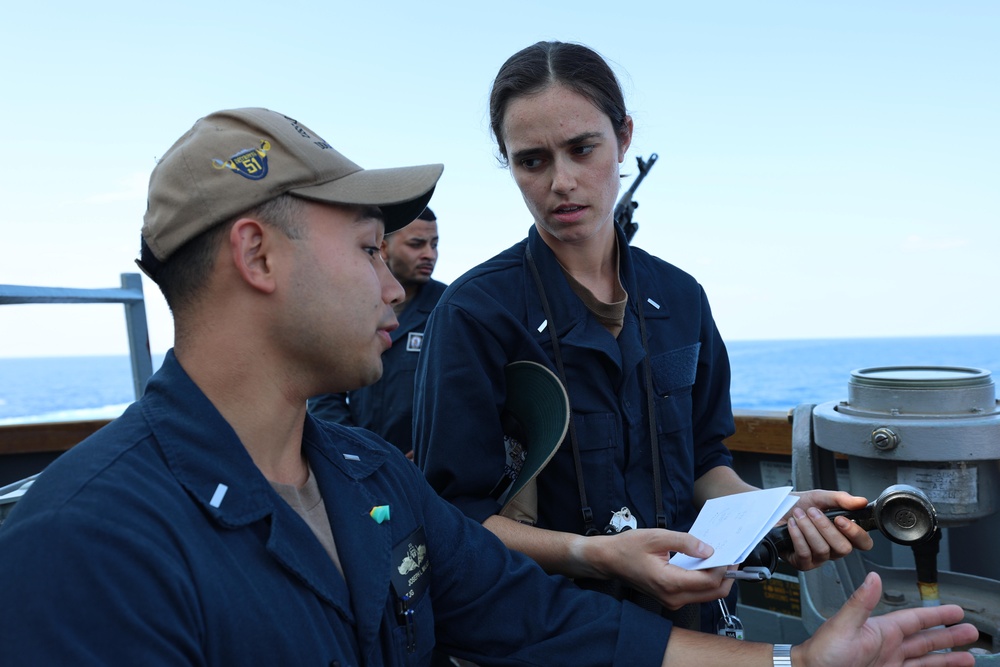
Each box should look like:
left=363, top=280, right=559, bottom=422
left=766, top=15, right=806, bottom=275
left=414, top=227, right=735, bottom=630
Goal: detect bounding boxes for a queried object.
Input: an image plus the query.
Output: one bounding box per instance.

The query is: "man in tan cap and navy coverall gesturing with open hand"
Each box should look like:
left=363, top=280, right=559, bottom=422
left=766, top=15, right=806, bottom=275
left=0, top=109, right=975, bottom=667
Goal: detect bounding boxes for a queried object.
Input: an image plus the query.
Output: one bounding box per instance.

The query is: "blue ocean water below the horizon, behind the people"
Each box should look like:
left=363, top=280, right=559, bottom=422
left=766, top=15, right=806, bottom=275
left=0, top=336, right=1000, bottom=424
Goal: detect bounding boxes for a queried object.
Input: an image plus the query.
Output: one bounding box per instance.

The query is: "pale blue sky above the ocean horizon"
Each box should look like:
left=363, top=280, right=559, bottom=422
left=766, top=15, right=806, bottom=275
left=0, top=0, right=1000, bottom=356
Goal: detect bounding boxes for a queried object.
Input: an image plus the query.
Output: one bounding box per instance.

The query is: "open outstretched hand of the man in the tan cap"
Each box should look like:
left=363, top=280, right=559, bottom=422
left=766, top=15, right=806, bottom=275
left=792, top=572, right=979, bottom=667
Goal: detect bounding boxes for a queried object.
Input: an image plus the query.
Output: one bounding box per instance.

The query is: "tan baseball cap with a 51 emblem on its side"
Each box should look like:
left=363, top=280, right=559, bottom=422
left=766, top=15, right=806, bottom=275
left=136, top=108, right=444, bottom=280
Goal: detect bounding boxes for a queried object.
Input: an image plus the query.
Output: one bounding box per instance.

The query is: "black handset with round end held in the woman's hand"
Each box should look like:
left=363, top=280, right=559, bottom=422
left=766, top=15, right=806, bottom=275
left=740, top=484, right=938, bottom=579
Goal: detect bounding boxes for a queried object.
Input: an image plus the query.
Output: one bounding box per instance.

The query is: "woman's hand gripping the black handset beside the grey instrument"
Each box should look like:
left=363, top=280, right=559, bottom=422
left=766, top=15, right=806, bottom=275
left=781, top=489, right=874, bottom=572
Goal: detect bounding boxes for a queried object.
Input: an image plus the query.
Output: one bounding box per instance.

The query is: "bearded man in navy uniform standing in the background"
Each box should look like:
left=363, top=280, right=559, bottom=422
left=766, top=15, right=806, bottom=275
left=309, top=207, right=447, bottom=459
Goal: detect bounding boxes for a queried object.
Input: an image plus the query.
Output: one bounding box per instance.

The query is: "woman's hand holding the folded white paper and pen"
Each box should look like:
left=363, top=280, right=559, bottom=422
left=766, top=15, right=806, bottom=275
left=587, top=528, right=733, bottom=609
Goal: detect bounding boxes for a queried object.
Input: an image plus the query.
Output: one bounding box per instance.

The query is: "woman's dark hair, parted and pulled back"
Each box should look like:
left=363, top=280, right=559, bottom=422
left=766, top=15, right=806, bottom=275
left=490, top=42, right=628, bottom=163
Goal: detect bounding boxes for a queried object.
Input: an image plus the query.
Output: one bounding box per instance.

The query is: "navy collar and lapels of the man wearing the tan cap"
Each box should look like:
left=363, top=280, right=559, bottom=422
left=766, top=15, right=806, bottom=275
left=142, top=351, right=392, bottom=636
